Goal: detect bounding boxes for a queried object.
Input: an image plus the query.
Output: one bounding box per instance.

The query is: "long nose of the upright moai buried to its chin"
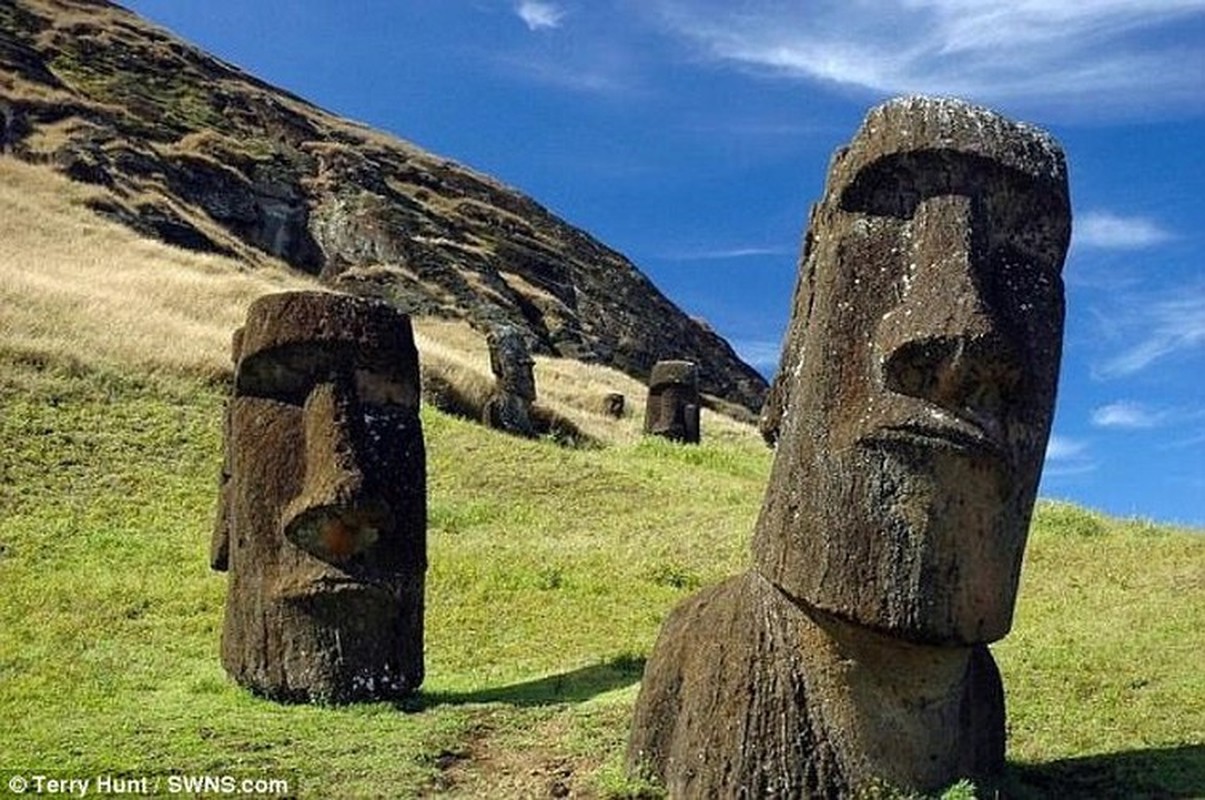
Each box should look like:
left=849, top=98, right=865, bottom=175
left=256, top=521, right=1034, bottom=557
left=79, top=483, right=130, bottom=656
left=281, top=382, right=393, bottom=564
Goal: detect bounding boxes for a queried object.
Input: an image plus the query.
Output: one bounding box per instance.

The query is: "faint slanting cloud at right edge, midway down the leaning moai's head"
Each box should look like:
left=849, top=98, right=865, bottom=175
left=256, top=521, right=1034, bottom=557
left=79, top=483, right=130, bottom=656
left=1094, top=293, right=1205, bottom=380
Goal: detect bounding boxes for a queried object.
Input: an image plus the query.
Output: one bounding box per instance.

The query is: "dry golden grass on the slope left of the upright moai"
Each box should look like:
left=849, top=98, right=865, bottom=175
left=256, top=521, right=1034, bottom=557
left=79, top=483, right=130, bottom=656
left=0, top=158, right=315, bottom=377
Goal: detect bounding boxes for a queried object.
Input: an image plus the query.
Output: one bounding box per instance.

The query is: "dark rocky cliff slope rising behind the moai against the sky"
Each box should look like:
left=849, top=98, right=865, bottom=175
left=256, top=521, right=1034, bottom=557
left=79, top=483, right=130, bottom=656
left=0, top=0, right=765, bottom=411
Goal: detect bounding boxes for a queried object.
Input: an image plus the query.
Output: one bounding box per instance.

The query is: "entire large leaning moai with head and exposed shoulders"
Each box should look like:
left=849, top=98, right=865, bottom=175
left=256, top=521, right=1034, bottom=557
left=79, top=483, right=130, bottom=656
left=628, top=98, right=1070, bottom=798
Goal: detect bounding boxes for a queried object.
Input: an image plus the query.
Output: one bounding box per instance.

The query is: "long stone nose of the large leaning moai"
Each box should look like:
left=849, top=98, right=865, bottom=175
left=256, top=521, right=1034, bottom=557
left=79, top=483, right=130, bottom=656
left=876, top=195, right=1023, bottom=420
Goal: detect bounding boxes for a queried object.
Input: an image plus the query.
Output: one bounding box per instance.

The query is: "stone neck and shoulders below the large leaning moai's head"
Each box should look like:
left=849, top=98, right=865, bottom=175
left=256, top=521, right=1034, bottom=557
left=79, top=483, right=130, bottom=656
left=628, top=572, right=1004, bottom=799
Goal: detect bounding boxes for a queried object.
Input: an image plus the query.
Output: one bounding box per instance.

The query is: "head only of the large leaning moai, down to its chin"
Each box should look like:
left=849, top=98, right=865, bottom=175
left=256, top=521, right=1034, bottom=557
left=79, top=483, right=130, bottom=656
left=754, top=98, right=1070, bottom=645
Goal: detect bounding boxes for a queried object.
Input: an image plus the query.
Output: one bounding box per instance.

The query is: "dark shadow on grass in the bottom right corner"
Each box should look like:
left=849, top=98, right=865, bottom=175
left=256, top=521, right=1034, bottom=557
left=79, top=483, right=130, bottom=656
left=1010, top=745, right=1205, bottom=800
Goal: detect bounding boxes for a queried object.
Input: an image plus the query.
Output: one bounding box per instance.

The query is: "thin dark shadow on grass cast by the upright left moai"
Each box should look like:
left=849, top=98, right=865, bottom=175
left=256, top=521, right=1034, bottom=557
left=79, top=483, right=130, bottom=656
left=401, top=655, right=645, bottom=711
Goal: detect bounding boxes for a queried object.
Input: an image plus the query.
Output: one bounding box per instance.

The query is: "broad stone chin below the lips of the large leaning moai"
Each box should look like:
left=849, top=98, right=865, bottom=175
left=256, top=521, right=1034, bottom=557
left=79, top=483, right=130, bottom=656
left=794, top=439, right=1028, bottom=646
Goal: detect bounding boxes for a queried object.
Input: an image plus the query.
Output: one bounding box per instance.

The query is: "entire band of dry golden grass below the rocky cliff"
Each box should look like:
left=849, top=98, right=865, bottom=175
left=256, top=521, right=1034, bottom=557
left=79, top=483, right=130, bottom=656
left=0, top=158, right=757, bottom=445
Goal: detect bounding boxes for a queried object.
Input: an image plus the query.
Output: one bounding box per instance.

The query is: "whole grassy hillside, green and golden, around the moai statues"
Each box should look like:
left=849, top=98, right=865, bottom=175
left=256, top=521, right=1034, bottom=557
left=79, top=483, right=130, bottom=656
left=0, top=153, right=1205, bottom=798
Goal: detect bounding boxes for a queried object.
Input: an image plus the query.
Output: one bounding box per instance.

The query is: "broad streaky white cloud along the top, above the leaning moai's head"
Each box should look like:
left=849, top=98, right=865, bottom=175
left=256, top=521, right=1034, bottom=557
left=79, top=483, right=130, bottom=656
left=652, top=0, right=1205, bottom=111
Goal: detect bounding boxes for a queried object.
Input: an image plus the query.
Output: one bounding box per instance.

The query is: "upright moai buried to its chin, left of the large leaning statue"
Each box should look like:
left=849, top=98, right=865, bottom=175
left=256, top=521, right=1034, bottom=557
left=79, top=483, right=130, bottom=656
left=211, top=292, right=427, bottom=702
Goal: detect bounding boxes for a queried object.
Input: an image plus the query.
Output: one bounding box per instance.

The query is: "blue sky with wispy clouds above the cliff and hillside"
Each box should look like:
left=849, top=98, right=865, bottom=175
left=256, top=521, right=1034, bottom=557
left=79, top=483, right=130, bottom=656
left=115, top=0, right=1205, bottom=527
